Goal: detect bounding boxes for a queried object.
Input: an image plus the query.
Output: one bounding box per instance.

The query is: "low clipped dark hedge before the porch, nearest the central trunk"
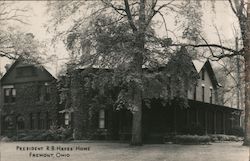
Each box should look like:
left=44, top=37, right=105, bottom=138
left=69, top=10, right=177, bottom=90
left=174, top=135, right=210, bottom=144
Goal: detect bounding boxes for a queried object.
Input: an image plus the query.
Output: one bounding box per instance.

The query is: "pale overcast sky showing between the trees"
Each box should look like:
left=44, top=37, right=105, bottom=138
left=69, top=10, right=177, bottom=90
left=0, top=1, right=238, bottom=75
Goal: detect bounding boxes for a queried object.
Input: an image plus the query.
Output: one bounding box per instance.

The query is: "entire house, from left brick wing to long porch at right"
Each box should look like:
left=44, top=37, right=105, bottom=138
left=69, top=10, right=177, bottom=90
left=0, top=50, right=241, bottom=141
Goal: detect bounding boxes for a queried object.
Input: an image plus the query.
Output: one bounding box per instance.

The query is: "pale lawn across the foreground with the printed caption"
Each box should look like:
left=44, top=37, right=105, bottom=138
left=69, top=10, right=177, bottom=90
left=0, top=141, right=249, bottom=161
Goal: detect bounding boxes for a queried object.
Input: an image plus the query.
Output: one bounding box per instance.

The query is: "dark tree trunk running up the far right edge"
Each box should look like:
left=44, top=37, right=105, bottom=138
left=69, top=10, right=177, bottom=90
left=242, top=0, right=250, bottom=145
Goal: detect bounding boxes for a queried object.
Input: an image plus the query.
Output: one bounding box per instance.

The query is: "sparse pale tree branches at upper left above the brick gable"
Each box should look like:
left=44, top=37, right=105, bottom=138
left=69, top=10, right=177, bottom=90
left=0, top=1, right=42, bottom=62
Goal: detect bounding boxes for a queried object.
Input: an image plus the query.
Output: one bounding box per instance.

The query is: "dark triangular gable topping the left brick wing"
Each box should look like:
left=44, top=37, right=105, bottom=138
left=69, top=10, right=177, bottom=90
left=1, top=59, right=55, bottom=85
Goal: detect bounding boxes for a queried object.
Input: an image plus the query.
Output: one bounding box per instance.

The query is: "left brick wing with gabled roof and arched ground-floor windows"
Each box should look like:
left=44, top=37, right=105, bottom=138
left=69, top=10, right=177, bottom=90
left=0, top=58, right=58, bottom=136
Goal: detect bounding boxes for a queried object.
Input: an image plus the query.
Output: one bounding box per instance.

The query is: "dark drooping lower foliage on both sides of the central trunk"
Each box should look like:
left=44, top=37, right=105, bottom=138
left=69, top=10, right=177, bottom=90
left=61, top=46, right=198, bottom=114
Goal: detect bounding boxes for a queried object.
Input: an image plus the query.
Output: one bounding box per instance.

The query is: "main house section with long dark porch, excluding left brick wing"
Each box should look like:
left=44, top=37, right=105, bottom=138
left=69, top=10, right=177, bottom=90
left=58, top=48, right=241, bottom=140
